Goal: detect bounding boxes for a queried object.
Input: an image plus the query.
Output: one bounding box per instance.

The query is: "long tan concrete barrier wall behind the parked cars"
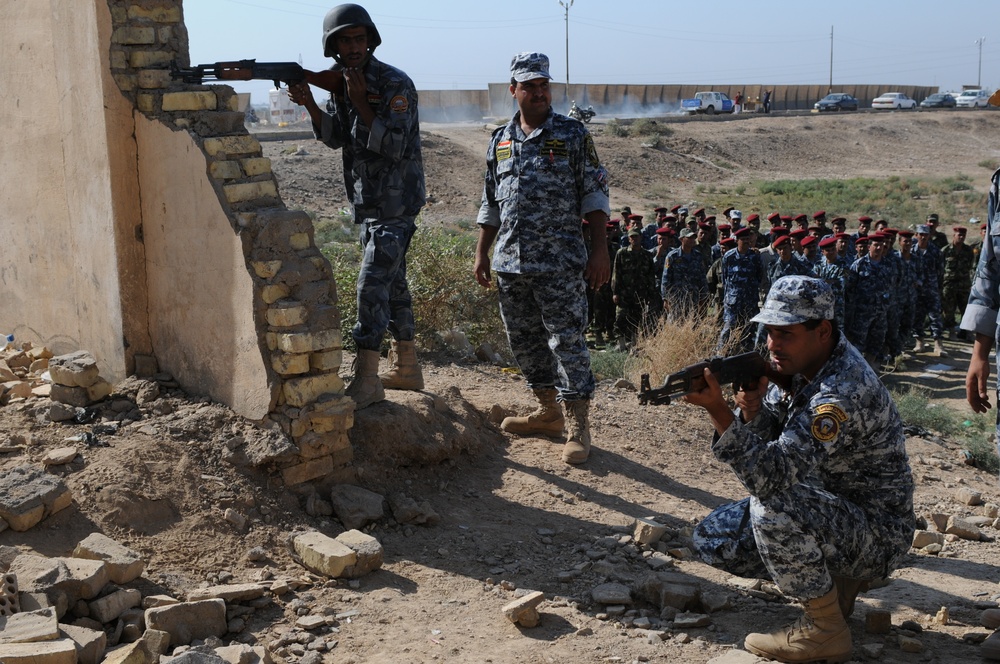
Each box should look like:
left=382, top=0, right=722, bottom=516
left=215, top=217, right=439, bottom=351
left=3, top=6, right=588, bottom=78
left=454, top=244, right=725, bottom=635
left=428, top=82, right=938, bottom=121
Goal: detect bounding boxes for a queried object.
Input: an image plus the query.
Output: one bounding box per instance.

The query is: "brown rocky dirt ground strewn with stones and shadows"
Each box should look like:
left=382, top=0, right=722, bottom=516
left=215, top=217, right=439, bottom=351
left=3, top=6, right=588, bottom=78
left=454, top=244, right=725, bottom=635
left=0, top=112, right=1000, bottom=664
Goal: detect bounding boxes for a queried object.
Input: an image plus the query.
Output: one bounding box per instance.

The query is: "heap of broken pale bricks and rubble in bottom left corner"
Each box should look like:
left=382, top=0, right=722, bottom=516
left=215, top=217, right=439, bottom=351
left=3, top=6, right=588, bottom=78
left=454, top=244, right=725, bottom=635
left=0, top=530, right=383, bottom=664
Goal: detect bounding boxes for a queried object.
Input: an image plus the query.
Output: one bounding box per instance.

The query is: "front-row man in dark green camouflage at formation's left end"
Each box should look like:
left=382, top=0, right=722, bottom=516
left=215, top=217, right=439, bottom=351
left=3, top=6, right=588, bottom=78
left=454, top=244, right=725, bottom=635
left=611, top=228, right=656, bottom=350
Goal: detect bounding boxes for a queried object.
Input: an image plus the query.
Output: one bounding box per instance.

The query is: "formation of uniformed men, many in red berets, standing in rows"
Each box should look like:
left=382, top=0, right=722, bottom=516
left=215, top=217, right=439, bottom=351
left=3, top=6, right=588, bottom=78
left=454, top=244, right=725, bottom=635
left=589, top=205, right=986, bottom=368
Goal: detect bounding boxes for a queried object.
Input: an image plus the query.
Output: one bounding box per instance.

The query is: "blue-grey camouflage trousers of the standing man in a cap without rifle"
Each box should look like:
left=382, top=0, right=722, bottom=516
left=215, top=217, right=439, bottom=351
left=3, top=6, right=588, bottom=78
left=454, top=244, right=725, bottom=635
left=496, top=272, right=594, bottom=401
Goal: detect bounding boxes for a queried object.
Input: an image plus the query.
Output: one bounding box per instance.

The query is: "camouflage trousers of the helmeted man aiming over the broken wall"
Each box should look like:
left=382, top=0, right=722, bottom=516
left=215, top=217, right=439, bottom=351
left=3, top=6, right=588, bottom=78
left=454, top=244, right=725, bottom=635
left=351, top=217, right=416, bottom=350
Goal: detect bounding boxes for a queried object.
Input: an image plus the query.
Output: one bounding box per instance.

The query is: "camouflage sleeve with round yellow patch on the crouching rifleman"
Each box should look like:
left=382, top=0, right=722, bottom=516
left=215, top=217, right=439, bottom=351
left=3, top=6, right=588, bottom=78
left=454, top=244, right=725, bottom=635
left=712, top=396, right=849, bottom=500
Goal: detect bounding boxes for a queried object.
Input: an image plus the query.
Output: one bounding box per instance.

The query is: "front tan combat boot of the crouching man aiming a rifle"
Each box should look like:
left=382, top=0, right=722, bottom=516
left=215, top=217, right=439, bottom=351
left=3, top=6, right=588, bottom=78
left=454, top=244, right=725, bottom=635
left=743, top=585, right=851, bottom=664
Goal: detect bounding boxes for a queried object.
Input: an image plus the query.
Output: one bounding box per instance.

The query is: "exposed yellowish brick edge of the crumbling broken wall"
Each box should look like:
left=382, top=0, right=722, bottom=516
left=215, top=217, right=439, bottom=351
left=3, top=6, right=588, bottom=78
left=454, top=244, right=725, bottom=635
left=108, top=0, right=354, bottom=484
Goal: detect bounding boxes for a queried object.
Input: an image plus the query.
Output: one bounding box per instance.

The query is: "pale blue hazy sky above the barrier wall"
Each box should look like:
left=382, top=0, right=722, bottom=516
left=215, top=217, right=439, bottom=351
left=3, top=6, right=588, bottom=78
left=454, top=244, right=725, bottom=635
left=184, top=0, right=1000, bottom=103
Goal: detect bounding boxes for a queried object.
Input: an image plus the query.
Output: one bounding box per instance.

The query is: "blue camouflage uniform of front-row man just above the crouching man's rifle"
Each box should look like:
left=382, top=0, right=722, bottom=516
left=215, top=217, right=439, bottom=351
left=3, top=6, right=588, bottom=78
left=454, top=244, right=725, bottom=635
left=719, top=248, right=763, bottom=352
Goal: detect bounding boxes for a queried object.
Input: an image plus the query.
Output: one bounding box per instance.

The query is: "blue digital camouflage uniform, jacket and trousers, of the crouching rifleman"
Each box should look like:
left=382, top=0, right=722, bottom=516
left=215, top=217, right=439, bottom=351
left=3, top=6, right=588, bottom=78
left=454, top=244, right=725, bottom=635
left=693, top=334, right=914, bottom=601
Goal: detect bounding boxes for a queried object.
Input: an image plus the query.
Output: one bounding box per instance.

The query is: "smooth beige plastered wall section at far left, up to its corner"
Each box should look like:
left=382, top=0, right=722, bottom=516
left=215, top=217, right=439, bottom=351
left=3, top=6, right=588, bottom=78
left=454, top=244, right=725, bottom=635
left=0, top=0, right=149, bottom=380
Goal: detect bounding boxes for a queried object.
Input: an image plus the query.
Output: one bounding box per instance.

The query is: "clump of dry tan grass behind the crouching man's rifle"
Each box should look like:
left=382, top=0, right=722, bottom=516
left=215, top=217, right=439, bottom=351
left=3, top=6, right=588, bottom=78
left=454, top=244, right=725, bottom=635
left=628, top=314, right=756, bottom=387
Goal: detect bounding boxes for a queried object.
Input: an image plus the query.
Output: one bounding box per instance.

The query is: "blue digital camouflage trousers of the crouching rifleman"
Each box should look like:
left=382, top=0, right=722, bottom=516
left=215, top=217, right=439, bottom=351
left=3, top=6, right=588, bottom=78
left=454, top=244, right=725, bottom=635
left=692, top=484, right=913, bottom=601
